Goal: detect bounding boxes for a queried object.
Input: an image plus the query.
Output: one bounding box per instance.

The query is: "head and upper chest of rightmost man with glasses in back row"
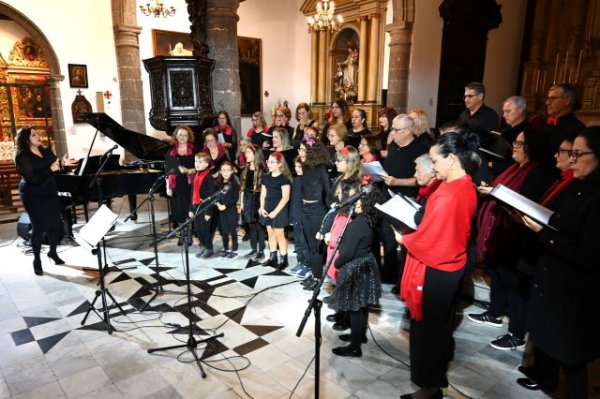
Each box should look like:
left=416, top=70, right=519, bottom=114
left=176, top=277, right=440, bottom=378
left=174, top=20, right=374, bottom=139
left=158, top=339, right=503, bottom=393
left=543, top=83, right=585, bottom=148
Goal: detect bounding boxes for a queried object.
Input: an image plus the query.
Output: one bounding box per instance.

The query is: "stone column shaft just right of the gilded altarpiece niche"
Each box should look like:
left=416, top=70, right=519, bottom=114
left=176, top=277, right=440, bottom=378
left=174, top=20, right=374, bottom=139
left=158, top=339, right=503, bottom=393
left=386, top=22, right=412, bottom=112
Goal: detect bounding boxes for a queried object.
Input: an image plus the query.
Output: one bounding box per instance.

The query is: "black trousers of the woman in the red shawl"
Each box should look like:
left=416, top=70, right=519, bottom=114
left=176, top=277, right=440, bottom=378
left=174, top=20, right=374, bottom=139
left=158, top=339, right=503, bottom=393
left=410, top=267, right=464, bottom=388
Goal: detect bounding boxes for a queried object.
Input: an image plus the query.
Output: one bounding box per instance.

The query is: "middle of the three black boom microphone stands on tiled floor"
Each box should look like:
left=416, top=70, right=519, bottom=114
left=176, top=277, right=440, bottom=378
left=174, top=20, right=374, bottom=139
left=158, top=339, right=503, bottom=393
left=148, top=195, right=225, bottom=378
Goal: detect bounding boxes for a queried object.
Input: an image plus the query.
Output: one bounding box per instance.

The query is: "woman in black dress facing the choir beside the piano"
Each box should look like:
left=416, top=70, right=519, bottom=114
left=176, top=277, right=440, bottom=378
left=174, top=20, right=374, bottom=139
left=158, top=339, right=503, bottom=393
left=15, top=127, right=72, bottom=276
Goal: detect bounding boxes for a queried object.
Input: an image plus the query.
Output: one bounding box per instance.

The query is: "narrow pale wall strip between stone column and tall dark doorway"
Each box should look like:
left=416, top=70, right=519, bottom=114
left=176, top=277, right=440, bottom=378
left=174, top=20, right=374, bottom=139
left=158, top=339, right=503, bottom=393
left=408, top=0, right=444, bottom=125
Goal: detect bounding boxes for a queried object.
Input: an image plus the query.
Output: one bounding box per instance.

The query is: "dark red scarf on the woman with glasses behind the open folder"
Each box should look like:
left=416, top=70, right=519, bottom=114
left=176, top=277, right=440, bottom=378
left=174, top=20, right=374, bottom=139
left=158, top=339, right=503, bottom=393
left=475, top=161, right=537, bottom=262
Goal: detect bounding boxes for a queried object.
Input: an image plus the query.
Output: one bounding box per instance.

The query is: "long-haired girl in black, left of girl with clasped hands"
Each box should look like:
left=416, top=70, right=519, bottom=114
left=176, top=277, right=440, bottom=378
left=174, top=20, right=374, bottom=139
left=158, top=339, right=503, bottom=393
left=240, top=145, right=267, bottom=260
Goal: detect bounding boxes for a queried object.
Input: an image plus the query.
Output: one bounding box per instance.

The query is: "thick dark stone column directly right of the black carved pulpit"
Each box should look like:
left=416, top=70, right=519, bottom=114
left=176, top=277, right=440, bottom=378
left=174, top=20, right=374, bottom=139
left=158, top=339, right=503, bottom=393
left=206, top=0, right=242, bottom=137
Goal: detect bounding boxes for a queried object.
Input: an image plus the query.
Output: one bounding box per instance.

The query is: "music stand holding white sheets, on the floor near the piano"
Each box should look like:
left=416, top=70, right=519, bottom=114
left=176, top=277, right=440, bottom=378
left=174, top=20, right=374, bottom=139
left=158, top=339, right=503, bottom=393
left=74, top=204, right=125, bottom=334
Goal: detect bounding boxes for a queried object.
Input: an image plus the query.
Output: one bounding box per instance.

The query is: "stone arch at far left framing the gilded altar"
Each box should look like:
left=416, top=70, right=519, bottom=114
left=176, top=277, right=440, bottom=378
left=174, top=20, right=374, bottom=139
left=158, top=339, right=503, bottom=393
left=0, top=3, right=67, bottom=154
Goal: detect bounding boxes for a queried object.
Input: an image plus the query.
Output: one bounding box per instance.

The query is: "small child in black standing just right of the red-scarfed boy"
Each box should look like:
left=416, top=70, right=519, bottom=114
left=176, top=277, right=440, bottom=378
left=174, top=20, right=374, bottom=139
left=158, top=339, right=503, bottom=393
left=215, top=161, right=240, bottom=259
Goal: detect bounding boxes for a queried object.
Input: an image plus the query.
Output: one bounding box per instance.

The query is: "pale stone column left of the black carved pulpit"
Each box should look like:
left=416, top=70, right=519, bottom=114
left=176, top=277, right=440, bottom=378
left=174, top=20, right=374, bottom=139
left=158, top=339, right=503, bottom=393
left=111, top=0, right=146, bottom=134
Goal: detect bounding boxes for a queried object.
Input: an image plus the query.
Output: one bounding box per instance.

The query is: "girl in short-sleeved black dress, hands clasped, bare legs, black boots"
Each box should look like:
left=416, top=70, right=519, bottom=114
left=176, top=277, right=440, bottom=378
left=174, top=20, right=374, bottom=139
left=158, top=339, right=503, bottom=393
left=258, top=152, right=292, bottom=269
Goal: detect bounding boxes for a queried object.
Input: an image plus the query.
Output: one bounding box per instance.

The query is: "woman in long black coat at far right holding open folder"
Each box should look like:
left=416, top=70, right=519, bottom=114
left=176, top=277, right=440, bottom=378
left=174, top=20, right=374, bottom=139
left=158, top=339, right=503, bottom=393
left=518, top=127, right=600, bottom=398
